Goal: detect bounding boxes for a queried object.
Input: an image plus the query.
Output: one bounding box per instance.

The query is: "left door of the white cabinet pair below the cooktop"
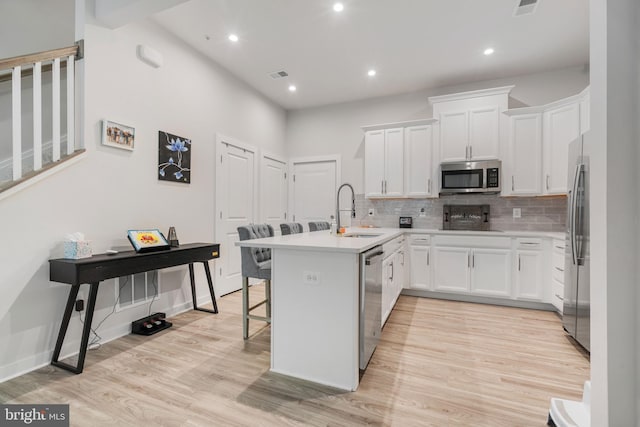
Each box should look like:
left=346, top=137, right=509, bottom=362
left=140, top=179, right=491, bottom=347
left=433, top=246, right=471, bottom=292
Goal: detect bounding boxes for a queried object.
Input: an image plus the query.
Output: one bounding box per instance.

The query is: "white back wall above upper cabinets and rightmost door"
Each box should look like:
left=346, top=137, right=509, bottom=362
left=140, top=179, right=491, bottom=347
left=286, top=67, right=589, bottom=193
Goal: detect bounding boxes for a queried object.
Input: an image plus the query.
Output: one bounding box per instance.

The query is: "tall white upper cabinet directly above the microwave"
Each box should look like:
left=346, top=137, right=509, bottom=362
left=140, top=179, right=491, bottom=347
left=429, top=86, right=513, bottom=162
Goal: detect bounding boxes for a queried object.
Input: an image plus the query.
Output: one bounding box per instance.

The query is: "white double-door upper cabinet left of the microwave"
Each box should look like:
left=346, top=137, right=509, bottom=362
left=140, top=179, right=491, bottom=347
left=363, top=119, right=435, bottom=198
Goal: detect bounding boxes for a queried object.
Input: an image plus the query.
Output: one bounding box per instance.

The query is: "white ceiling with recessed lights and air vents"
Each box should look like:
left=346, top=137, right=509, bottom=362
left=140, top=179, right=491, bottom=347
left=152, top=0, right=589, bottom=109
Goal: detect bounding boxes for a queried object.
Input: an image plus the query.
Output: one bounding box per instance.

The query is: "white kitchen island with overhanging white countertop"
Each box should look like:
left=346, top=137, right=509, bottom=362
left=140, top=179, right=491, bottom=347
left=236, top=228, right=402, bottom=390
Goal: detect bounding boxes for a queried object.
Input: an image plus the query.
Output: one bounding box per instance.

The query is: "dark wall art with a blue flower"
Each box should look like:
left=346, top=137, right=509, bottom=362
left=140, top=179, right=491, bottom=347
left=158, top=131, right=191, bottom=184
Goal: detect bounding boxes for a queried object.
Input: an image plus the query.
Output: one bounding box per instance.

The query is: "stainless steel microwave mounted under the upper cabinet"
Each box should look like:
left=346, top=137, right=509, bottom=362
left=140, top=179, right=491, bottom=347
left=440, top=160, right=502, bottom=194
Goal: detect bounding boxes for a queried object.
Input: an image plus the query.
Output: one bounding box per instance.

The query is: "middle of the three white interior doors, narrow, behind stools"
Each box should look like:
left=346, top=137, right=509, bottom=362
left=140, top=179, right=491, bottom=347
left=260, top=155, right=288, bottom=234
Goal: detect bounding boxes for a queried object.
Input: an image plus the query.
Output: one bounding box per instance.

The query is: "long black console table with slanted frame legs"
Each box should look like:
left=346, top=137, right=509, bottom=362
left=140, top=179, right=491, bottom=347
left=49, top=243, right=220, bottom=374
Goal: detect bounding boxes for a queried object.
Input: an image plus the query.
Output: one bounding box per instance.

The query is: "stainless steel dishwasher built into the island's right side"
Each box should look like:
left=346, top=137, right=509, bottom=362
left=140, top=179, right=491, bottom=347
left=360, top=246, right=384, bottom=370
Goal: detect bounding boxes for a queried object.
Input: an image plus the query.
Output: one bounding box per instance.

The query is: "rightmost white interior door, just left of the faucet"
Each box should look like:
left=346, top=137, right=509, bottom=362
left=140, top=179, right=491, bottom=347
left=290, top=159, right=339, bottom=230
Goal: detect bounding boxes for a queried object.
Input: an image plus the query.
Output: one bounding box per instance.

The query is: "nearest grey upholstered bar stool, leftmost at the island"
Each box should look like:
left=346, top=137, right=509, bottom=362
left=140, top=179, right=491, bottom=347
left=238, top=224, right=274, bottom=339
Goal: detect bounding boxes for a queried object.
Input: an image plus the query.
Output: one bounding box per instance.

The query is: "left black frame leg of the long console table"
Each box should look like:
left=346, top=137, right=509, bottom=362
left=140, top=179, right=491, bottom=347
left=51, top=282, right=98, bottom=374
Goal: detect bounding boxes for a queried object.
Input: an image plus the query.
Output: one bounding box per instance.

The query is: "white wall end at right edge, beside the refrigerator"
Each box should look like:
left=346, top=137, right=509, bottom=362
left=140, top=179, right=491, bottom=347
left=586, top=0, right=640, bottom=427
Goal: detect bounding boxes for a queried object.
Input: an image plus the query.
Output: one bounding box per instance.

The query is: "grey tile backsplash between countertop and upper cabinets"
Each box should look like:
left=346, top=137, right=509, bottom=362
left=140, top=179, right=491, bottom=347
left=353, top=194, right=567, bottom=232
